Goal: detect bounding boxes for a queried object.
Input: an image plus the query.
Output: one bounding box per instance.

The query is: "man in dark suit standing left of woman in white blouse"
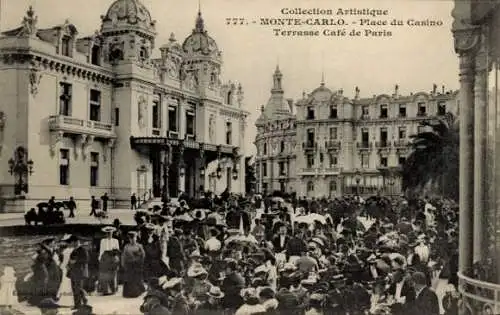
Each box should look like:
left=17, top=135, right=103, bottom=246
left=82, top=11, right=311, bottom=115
left=67, top=235, right=89, bottom=309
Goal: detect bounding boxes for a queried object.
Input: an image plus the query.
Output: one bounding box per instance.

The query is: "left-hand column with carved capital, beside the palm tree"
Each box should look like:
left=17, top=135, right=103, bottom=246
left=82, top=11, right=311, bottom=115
left=453, top=28, right=479, bottom=272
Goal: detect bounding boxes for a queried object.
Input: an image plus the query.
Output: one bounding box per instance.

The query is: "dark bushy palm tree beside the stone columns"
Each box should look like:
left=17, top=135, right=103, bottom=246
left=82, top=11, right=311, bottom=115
left=402, top=112, right=460, bottom=201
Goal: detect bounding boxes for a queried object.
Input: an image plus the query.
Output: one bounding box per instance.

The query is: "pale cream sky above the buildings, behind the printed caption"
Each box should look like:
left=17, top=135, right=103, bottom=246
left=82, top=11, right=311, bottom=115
left=0, top=0, right=458, bottom=155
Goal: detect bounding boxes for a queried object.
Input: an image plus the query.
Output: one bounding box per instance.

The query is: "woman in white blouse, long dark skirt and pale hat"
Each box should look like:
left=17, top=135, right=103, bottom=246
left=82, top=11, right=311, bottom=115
left=99, top=226, right=120, bottom=295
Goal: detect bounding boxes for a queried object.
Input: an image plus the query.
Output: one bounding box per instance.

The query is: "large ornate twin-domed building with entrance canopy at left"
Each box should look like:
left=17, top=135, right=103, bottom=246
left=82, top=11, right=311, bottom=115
left=0, top=0, right=248, bottom=211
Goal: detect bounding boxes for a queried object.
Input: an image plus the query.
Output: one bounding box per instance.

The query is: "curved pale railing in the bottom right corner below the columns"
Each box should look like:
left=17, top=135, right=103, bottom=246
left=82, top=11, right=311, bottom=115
left=458, top=272, right=500, bottom=314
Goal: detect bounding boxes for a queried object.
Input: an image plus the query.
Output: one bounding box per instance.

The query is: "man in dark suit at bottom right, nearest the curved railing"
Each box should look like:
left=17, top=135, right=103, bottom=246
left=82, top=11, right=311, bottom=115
left=408, top=272, right=439, bottom=315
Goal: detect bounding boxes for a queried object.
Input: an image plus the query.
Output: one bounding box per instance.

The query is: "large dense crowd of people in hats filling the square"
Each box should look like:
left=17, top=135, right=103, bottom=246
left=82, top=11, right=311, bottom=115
left=23, top=193, right=458, bottom=315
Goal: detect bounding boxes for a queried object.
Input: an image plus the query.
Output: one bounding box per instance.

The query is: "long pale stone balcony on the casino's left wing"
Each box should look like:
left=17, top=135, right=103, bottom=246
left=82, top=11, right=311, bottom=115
left=49, top=115, right=116, bottom=139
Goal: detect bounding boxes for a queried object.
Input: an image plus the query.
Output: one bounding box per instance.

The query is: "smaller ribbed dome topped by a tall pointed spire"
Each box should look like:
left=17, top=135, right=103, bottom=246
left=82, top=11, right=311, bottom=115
left=182, top=12, right=220, bottom=56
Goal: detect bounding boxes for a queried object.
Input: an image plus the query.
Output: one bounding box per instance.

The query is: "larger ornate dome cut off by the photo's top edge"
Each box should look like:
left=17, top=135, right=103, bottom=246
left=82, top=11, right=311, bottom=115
left=101, top=0, right=156, bottom=33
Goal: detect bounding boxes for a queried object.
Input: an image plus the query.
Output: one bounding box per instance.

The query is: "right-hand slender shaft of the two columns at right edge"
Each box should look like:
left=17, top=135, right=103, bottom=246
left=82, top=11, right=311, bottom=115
left=472, top=35, right=488, bottom=263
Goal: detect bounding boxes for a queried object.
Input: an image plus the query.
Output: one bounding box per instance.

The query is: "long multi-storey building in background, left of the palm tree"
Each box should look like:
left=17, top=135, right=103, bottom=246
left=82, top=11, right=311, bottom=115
left=255, top=67, right=458, bottom=198
